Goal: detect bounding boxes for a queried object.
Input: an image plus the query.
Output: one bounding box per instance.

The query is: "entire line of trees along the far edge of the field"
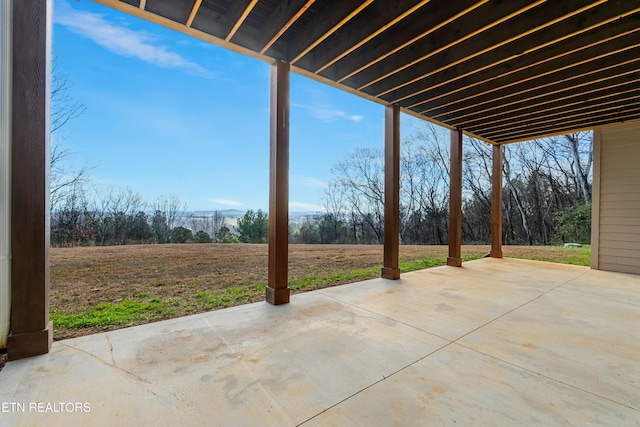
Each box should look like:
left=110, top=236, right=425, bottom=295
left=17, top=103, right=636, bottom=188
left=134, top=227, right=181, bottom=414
left=51, top=125, right=593, bottom=246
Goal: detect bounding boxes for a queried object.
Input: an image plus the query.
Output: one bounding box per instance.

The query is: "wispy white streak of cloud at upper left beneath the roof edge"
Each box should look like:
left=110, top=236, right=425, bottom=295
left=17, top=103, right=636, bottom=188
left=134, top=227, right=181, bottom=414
left=54, top=1, right=211, bottom=77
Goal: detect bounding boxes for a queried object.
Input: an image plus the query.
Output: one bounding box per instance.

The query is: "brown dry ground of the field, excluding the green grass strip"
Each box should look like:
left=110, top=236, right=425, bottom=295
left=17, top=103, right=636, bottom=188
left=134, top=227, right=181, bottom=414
left=50, top=244, right=584, bottom=340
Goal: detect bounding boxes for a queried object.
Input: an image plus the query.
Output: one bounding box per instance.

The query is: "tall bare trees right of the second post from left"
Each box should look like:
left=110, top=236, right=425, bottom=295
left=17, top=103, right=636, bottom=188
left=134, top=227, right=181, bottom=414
left=295, top=124, right=593, bottom=245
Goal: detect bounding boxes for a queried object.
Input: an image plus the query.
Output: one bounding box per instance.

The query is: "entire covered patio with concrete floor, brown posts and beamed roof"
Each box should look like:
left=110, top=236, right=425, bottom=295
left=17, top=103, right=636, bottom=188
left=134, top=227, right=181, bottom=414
left=0, top=4, right=640, bottom=426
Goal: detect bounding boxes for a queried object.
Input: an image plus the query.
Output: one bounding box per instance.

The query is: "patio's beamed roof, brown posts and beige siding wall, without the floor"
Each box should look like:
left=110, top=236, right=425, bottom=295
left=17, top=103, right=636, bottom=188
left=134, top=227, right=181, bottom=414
left=0, top=0, right=640, bottom=360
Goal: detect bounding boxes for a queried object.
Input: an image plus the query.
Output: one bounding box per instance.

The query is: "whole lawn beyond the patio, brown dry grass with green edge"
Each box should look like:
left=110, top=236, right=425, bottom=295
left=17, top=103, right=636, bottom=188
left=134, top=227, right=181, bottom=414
left=51, top=244, right=592, bottom=339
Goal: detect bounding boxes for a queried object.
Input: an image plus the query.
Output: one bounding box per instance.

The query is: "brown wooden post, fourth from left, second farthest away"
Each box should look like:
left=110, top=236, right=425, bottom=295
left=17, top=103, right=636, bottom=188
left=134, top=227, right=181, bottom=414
left=447, top=129, right=462, bottom=267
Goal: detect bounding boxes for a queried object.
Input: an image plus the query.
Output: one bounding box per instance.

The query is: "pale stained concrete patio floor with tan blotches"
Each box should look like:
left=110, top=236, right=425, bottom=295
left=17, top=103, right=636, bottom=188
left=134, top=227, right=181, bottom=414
left=0, top=259, right=640, bottom=426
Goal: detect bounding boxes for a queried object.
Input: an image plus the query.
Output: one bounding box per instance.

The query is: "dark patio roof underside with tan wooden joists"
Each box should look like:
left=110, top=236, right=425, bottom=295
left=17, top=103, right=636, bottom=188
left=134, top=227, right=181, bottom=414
left=96, top=0, right=640, bottom=144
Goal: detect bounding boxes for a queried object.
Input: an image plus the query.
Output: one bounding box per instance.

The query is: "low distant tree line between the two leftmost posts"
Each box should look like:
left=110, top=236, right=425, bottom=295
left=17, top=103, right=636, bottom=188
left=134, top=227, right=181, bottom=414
left=50, top=184, right=276, bottom=247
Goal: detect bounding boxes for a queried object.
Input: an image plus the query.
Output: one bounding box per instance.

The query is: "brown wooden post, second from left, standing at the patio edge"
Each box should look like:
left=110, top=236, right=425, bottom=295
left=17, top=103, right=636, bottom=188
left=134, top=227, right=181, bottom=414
left=266, top=61, right=290, bottom=305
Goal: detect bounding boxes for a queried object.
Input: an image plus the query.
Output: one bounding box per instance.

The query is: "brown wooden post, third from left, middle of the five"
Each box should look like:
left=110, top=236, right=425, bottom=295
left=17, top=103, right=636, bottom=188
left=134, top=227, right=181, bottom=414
left=382, top=105, right=400, bottom=280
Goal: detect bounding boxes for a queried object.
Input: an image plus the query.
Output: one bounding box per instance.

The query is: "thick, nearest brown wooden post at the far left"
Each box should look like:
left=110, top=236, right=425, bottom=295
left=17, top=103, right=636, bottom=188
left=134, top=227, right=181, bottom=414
left=7, top=0, right=53, bottom=360
